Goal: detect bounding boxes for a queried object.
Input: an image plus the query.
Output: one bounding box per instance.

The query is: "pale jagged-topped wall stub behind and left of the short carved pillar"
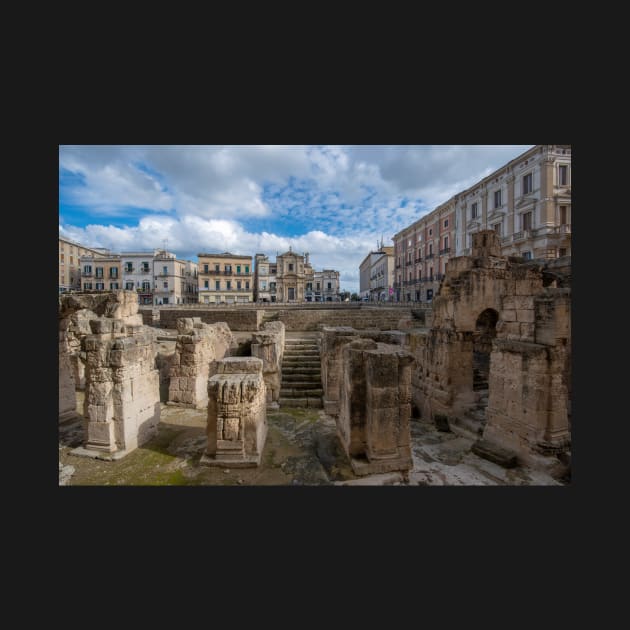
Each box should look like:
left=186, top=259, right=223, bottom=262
left=168, top=317, right=233, bottom=409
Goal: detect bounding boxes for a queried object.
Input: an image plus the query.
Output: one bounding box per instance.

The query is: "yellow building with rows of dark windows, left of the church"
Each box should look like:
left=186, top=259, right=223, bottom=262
left=197, top=252, right=254, bottom=304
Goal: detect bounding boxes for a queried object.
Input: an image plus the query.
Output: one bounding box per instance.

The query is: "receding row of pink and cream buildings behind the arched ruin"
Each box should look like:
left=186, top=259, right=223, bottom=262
left=393, top=145, right=571, bottom=302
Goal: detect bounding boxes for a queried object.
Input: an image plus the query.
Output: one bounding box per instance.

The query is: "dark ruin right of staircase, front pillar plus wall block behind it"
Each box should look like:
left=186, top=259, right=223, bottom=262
left=321, top=327, right=413, bottom=475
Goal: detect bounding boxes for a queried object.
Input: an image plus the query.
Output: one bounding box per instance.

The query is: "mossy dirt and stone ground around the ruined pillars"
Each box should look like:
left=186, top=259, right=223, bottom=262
left=59, top=392, right=563, bottom=486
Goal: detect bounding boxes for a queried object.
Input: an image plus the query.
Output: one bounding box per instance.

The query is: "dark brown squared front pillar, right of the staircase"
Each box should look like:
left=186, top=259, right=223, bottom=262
left=336, top=339, right=413, bottom=475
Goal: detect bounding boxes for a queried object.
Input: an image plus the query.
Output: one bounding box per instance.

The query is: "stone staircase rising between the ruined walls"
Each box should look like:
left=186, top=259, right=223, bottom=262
left=279, top=337, right=323, bottom=409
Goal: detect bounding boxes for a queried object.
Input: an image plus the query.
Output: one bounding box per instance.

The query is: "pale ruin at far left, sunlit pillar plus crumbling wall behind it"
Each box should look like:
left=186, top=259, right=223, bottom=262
left=59, top=291, right=160, bottom=458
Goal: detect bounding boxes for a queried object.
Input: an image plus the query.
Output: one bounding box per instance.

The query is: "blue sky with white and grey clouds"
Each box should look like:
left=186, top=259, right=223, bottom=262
left=59, top=145, right=533, bottom=293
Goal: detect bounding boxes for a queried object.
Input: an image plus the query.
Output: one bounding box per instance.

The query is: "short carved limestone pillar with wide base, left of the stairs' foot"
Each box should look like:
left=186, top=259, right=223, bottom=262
left=200, top=357, right=267, bottom=468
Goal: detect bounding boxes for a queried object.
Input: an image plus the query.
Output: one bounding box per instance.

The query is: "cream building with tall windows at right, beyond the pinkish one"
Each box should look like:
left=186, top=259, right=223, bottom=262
left=456, top=144, right=571, bottom=259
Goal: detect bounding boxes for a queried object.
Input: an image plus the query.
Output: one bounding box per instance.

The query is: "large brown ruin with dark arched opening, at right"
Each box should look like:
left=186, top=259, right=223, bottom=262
left=409, top=230, right=571, bottom=474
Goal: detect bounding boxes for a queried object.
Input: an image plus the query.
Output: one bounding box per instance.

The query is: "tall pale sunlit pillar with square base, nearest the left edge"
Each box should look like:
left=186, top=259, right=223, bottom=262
left=76, top=317, right=160, bottom=457
